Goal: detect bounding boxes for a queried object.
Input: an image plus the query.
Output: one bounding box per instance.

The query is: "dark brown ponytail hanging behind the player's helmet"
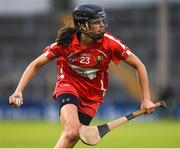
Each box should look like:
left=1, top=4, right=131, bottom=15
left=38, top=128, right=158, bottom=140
left=56, top=27, right=77, bottom=47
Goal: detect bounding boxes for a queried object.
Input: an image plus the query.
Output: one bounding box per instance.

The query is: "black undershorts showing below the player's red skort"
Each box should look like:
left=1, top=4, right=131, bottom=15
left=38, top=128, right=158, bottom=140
left=56, top=94, right=93, bottom=125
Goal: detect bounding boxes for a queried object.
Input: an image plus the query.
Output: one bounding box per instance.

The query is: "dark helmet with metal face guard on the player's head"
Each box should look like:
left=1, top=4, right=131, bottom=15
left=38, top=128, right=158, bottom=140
left=73, top=4, right=108, bottom=40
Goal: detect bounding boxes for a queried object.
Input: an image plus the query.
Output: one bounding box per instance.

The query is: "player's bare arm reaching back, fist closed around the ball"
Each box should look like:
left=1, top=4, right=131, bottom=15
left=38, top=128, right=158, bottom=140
left=9, top=54, right=51, bottom=107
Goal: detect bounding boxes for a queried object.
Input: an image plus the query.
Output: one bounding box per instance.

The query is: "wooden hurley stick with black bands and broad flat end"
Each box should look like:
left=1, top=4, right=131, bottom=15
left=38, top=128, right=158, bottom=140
left=79, top=101, right=166, bottom=145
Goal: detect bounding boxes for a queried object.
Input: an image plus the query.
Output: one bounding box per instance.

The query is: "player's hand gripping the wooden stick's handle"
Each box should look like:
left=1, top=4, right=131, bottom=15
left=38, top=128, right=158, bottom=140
left=141, top=100, right=155, bottom=114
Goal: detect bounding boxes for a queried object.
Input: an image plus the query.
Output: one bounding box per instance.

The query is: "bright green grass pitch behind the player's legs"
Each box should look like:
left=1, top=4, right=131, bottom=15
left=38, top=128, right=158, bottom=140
left=0, top=120, right=180, bottom=148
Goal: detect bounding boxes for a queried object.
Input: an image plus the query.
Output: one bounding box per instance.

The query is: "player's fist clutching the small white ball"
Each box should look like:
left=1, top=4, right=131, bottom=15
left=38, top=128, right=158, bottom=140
left=9, top=92, right=23, bottom=108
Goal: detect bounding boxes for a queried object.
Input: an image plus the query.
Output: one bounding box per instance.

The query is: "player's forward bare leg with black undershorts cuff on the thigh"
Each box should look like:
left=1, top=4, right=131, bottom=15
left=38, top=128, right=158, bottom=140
left=55, top=94, right=80, bottom=148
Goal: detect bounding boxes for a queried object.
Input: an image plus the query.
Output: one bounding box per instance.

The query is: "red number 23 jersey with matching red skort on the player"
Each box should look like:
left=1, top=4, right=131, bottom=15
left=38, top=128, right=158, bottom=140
left=44, top=32, right=131, bottom=116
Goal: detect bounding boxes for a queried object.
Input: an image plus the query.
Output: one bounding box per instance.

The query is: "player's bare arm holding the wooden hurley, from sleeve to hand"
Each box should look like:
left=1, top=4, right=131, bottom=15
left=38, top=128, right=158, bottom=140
left=124, top=53, right=155, bottom=113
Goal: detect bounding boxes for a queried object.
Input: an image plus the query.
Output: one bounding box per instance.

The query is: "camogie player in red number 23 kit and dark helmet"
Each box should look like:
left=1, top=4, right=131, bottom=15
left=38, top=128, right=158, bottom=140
left=9, top=4, right=154, bottom=148
